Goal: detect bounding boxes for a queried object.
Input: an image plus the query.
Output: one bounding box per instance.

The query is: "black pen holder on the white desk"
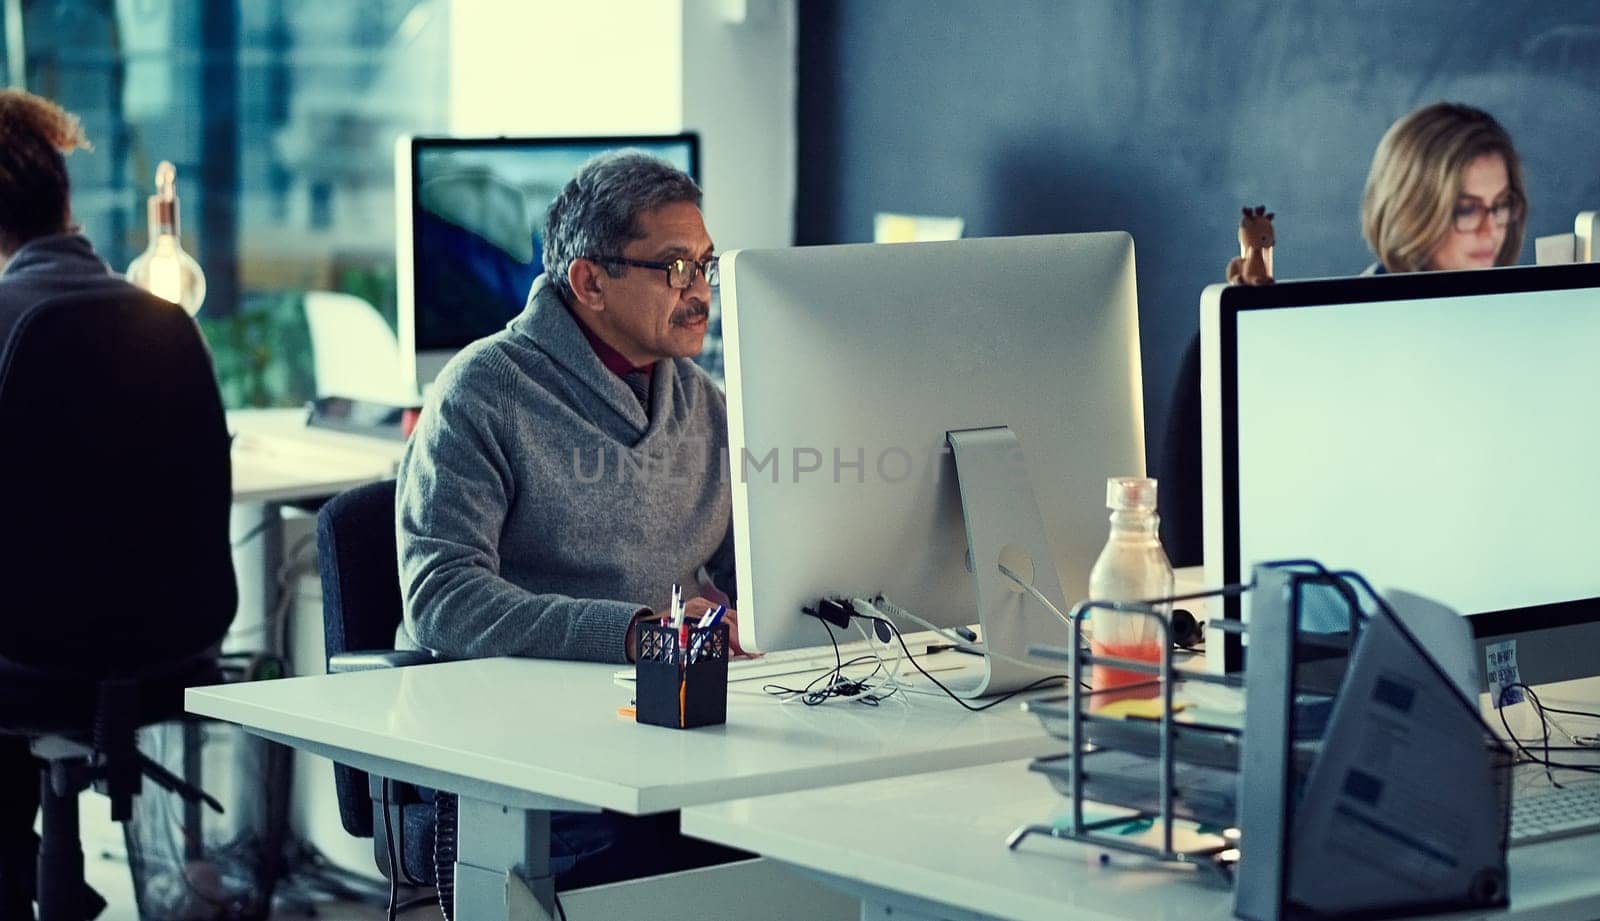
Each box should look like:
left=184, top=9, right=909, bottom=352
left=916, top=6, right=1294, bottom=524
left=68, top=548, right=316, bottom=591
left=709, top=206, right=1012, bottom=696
left=634, top=624, right=728, bottom=729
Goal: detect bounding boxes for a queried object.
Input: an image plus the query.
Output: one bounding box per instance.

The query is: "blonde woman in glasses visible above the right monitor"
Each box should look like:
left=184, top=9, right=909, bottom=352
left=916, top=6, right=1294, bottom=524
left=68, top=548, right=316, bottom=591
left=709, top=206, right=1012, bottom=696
left=1362, top=102, right=1528, bottom=273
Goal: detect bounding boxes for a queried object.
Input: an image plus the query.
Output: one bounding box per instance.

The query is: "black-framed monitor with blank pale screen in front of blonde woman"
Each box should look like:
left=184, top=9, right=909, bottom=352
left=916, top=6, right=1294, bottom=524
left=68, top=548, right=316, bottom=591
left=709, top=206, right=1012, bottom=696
left=1200, top=264, right=1600, bottom=683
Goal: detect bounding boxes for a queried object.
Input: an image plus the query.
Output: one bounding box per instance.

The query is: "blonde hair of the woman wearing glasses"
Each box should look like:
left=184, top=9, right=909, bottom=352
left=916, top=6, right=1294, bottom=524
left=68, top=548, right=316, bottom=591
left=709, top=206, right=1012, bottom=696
left=1362, top=102, right=1528, bottom=272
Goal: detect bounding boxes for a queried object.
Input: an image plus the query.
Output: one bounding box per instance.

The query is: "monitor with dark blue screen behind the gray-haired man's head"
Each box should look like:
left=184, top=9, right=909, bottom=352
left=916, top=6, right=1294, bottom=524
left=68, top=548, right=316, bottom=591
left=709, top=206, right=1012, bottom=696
left=395, top=134, right=699, bottom=392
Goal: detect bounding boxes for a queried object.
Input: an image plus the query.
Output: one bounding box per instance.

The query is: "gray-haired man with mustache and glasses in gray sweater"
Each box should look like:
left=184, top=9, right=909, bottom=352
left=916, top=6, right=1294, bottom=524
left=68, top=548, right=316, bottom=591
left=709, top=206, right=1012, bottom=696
left=397, top=150, right=738, bottom=887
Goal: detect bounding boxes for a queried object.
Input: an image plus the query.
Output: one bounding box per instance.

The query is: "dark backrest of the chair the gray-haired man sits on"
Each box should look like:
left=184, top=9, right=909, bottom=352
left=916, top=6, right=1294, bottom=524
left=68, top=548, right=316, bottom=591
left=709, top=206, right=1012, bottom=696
left=317, top=480, right=402, bottom=838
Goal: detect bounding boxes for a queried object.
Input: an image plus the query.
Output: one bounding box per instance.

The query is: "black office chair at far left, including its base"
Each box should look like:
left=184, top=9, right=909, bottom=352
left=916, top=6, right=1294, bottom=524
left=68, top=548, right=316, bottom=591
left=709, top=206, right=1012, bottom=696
left=0, top=280, right=238, bottom=921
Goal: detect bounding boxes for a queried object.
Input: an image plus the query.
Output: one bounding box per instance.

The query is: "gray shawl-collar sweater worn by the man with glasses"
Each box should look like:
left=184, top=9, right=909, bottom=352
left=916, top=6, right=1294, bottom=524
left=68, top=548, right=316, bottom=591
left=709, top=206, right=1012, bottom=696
left=395, top=275, right=733, bottom=662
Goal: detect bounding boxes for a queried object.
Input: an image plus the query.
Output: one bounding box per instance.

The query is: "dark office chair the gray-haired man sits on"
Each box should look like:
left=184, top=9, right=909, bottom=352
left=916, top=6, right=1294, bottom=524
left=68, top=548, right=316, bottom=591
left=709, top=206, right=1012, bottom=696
left=317, top=480, right=448, bottom=886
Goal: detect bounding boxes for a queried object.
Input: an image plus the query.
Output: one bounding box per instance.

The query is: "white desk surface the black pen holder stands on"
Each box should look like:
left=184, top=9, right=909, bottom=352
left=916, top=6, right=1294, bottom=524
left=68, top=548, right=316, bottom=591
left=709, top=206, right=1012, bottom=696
left=186, top=659, right=1061, bottom=815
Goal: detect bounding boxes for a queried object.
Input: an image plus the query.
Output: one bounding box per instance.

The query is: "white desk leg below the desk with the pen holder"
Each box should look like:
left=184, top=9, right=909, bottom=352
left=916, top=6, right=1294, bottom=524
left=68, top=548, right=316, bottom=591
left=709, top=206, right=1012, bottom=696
left=456, top=796, right=555, bottom=921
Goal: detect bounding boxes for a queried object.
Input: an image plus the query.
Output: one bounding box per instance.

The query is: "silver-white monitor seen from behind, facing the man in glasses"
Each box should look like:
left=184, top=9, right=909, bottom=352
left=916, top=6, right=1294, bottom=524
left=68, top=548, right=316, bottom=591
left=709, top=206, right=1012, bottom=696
left=722, top=233, right=1144, bottom=692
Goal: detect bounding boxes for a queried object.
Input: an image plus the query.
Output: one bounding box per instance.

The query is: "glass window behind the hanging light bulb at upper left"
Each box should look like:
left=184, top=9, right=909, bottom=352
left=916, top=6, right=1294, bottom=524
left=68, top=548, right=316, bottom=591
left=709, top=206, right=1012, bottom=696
left=25, top=0, right=448, bottom=406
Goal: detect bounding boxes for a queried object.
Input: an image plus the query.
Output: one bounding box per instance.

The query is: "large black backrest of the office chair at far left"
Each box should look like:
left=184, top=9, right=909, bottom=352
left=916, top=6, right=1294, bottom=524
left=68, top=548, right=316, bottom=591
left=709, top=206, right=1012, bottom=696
left=0, top=285, right=238, bottom=680
